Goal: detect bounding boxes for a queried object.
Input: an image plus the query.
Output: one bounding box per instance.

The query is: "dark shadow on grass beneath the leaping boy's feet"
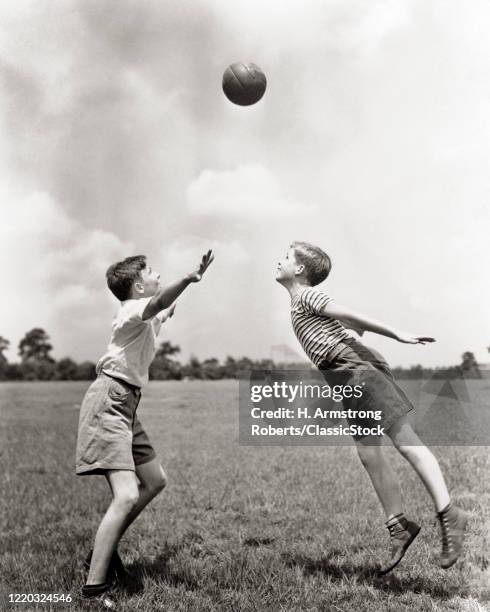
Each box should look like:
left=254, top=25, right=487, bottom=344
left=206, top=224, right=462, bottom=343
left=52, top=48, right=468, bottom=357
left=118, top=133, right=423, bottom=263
left=282, top=551, right=463, bottom=599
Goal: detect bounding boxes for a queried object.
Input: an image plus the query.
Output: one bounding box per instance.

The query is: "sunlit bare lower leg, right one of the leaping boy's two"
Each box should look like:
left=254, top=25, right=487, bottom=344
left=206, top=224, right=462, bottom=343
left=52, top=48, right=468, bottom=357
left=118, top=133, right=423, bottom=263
left=387, top=417, right=449, bottom=512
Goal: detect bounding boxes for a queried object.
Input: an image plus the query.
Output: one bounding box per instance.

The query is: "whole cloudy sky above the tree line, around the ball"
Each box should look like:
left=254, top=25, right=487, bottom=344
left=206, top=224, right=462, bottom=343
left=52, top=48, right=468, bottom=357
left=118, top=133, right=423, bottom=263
left=0, top=0, right=490, bottom=366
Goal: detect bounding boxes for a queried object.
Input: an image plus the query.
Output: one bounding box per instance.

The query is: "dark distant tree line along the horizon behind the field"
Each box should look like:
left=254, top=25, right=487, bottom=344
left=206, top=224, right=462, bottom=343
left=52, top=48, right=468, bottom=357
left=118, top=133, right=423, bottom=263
left=0, top=327, right=481, bottom=381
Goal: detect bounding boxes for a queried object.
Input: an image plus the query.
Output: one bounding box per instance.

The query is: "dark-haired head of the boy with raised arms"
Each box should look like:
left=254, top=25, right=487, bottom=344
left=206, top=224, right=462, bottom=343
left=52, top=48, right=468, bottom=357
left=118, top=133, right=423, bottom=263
left=106, top=255, right=160, bottom=302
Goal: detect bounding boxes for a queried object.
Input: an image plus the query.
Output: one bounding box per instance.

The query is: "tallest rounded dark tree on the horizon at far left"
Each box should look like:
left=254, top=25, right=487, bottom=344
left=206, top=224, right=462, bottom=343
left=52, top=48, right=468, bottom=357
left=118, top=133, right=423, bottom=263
left=19, top=327, right=56, bottom=380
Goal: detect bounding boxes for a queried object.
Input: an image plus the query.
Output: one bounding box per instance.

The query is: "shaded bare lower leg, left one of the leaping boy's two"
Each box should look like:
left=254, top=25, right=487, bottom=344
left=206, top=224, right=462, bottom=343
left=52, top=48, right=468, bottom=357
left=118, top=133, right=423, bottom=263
left=356, top=436, right=403, bottom=519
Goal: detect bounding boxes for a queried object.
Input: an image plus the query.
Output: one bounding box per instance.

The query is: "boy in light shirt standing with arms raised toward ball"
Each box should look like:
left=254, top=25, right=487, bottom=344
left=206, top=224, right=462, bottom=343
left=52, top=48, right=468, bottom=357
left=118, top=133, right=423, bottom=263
left=76, top=251, right=213, bottom=608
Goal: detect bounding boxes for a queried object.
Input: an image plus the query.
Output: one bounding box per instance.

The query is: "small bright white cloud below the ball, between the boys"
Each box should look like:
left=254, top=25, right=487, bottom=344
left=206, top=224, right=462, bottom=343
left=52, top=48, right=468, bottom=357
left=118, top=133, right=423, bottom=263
left=187, top=164, right=311, bottom=222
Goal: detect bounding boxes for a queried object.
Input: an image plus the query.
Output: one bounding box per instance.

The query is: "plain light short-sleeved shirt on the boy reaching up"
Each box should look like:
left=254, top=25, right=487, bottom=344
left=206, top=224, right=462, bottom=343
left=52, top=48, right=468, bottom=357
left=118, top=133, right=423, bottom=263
left=96, top=297, right=162, bottom=387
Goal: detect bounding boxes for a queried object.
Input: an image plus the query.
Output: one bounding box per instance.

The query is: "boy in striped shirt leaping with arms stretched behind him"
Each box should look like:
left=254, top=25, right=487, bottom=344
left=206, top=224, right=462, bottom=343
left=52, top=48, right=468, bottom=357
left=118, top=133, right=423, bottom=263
left=276, top=242, right=468, bottom=574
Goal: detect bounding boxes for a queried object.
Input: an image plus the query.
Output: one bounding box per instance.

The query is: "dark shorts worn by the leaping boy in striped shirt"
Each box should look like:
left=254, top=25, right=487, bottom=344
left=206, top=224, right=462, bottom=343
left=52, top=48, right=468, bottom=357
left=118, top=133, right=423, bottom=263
left=319, top=338, right=414, bottom=440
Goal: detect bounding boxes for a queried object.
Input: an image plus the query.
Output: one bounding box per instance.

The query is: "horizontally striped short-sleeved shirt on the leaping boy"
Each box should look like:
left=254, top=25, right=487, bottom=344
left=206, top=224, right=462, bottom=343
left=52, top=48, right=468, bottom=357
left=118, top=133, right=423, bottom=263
left=291, top=287, right=351, bottom=367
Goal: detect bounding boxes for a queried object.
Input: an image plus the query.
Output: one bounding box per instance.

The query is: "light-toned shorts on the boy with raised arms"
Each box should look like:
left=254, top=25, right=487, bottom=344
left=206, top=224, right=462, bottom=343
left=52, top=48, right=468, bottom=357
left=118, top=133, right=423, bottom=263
left=76, top=373, right=156, bottom=475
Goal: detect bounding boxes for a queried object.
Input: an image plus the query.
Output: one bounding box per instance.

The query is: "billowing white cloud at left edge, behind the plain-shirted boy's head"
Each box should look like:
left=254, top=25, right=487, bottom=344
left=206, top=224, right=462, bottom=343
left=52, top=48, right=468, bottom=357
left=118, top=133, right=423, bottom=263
left=0, top=190, right=133, bottom=359
